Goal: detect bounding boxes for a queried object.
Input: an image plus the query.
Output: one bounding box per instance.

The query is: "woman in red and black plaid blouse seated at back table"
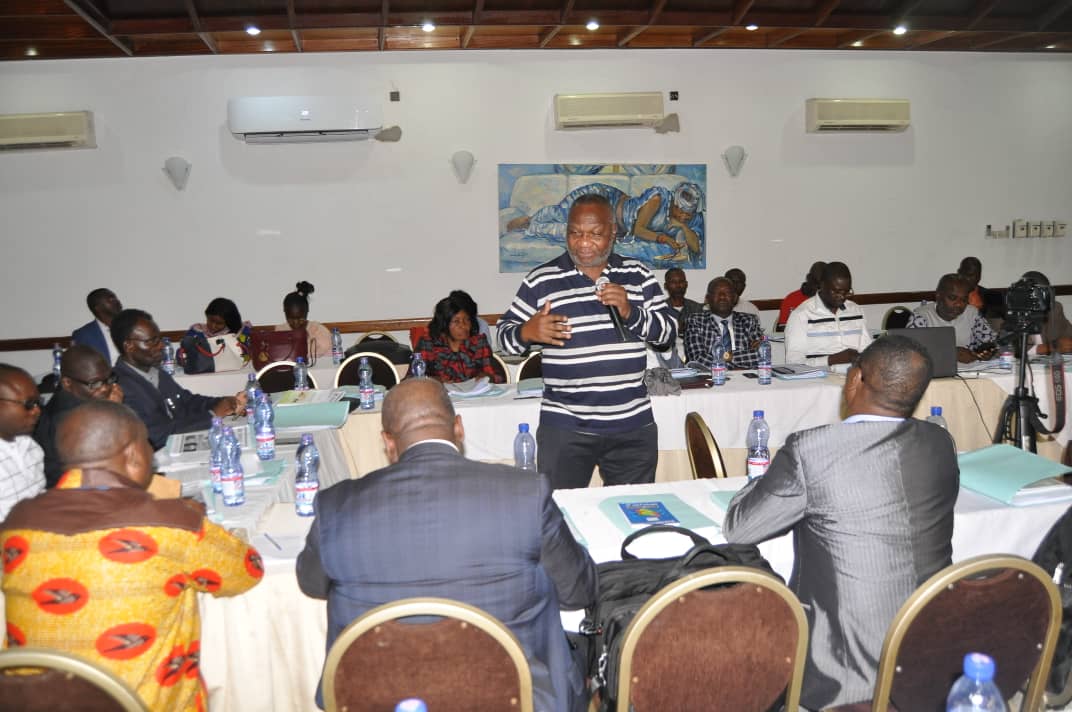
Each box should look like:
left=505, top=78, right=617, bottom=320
left=416, top=297, right=503, bottom=383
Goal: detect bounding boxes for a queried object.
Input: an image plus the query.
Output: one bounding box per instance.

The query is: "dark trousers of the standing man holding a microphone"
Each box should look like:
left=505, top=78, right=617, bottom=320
left=536, top=422, right=659, bottom=489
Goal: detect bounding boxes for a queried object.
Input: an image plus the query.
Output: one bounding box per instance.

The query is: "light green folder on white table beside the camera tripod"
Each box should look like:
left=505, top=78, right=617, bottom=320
left=957, top=445, right=1072, bottom=504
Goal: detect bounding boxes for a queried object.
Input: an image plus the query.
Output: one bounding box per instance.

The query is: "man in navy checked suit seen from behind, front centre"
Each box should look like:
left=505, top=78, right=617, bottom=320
left=297, top=379, right=596, bottom=712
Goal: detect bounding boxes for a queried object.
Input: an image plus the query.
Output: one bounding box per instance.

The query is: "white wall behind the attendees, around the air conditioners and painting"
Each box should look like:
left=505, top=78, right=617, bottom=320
left=0, top=50, right=1072, bottom=353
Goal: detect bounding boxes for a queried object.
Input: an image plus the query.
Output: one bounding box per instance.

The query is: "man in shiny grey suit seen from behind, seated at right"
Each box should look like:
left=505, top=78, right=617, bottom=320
left=724, top=337, right=959, bottom=710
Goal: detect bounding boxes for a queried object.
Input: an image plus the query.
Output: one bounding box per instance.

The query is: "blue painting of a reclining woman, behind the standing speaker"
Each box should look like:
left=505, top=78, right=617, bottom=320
left=498, top=163, right=708, bottom=272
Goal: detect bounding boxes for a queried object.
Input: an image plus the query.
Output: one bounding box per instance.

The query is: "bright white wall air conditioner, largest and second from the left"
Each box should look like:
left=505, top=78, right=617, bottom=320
left=227, top=97, right=384, bottom=144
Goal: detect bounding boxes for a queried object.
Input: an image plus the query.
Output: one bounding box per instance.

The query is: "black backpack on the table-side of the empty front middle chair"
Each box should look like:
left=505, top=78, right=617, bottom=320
left=575, top=524, right=781, bottom=711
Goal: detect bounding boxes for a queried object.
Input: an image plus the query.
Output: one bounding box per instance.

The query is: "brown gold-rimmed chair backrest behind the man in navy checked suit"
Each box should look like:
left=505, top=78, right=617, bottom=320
left=324, top=598, right=533, bottom=712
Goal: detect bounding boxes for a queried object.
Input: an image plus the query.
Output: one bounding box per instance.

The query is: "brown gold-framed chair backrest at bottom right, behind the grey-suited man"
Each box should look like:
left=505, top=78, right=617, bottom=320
left=872, top=555, right=1061, bottom=712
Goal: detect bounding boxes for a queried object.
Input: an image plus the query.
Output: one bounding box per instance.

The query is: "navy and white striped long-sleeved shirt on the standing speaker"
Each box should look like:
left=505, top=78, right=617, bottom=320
left=497, top=252, right=676, bottom=433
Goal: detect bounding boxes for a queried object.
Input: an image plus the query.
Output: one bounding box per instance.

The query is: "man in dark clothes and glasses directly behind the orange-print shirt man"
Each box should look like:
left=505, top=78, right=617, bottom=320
left=33, top=343, right=123, bottom=487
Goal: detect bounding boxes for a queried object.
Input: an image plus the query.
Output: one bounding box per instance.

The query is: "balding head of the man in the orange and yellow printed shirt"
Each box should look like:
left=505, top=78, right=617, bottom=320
left=56, top=400, right=152, bottom=485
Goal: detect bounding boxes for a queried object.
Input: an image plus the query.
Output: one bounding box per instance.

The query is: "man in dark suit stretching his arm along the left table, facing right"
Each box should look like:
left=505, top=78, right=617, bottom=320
left=111, top=309, right=245, bottom=449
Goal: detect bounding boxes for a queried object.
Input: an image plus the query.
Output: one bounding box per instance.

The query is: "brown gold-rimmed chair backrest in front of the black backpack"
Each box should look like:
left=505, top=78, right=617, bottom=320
left=617, top=566, right=808, bottom=712
